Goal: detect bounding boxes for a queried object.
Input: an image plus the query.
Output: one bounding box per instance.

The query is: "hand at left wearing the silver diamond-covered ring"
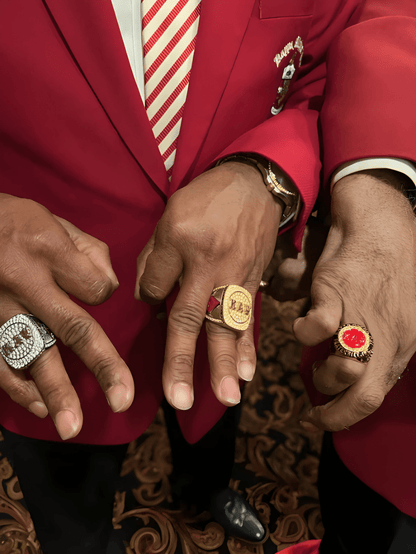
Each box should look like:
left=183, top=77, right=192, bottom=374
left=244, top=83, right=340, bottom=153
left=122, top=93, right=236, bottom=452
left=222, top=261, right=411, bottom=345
left=0, top=194, right=134, bottom=440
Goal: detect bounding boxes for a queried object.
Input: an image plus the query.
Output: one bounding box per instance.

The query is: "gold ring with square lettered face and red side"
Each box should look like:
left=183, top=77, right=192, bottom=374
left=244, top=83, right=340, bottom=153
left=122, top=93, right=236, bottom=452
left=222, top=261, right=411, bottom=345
left=205, top=285, right=253, bottom=331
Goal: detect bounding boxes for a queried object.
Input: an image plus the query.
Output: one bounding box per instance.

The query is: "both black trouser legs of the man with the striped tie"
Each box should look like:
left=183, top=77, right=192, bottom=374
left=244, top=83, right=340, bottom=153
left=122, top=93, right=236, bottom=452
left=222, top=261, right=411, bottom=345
left=2, top=403, right=239, bottom=554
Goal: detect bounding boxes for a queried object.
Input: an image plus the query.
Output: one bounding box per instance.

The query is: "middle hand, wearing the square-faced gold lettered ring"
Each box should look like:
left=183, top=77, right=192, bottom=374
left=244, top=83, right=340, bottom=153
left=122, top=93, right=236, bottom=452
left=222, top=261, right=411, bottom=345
left=136, top=162, right=282, bottom=410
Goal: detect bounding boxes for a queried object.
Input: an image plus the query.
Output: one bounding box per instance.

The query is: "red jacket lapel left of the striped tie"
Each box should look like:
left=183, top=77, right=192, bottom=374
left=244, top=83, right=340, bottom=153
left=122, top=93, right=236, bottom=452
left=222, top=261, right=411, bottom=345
left=43, top=0, right=168, bottom=194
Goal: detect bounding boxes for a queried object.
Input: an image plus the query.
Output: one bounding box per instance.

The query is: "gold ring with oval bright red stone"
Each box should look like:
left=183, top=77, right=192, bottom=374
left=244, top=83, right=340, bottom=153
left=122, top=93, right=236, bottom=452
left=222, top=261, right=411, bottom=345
left=332, top=323, right=374, bottom=363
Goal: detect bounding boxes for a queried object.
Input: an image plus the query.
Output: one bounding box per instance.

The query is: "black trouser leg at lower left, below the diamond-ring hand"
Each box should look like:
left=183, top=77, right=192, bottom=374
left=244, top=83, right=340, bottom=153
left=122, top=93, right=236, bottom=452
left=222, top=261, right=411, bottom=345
left=2, top=428, right=127, bottom=554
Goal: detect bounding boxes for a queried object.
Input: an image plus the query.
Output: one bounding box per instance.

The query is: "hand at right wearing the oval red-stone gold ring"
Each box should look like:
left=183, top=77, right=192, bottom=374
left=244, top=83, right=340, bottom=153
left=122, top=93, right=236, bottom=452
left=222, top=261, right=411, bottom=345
left=294, top=171, right=416, bottom=431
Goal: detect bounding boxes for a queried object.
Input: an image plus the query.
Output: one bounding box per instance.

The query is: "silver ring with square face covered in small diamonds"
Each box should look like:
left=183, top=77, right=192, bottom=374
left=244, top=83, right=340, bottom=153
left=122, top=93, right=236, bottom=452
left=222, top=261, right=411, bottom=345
left=0, top=314, right=56, bottom=369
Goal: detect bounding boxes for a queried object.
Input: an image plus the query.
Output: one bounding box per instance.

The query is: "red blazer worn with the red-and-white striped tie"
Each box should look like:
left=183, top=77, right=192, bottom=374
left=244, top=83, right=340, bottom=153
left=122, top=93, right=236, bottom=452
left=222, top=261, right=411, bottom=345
left=0, top=0, right=358, bottom=444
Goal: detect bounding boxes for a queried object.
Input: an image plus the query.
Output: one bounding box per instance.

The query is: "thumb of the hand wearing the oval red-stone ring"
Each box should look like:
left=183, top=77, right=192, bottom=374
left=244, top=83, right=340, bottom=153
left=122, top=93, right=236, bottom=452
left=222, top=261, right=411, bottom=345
left=293, top=277, right=343, bottom=346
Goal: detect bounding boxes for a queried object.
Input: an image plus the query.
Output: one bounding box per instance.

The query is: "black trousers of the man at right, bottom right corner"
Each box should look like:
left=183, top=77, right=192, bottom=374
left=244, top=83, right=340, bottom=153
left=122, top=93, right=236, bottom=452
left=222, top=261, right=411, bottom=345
left=318, top=433, right=416, bottom=554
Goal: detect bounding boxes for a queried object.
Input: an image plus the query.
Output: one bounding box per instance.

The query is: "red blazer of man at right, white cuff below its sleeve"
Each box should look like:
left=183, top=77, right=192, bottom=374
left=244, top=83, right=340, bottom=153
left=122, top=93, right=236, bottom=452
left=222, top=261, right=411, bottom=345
left=302, top=0, right=416, bottom=517
